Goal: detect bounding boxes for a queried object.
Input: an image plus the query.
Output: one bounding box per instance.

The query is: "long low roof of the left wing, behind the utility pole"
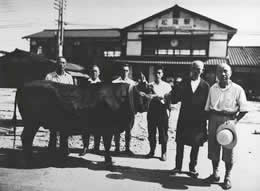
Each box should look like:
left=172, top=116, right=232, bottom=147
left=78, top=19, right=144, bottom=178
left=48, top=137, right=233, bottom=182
left=23, top=29, right=120, bottom=38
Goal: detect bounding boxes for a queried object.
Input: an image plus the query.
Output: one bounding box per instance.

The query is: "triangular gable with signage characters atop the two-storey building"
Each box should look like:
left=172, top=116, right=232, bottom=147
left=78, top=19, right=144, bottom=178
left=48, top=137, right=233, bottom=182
left=123, top=5, right=236, bottom=33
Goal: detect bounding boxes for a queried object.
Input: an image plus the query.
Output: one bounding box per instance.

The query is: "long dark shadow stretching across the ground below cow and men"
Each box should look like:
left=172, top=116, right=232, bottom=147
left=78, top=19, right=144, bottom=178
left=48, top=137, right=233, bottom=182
left=0, top=147, right=214, bottom=190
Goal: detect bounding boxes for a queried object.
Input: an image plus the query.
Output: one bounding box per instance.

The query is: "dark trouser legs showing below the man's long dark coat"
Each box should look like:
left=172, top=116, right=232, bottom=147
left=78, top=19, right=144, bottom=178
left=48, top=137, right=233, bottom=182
left=175, top=143, right=199, bottom=170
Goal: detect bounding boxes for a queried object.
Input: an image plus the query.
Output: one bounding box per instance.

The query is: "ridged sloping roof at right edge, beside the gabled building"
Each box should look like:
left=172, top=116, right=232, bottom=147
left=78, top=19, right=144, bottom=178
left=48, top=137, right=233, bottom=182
left=228, top=46, right=260, bottom=66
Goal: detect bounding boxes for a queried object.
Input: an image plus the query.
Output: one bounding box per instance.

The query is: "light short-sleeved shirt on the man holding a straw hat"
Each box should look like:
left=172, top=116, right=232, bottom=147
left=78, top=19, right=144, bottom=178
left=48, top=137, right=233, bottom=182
left=205, top=82, right=248, bottom=113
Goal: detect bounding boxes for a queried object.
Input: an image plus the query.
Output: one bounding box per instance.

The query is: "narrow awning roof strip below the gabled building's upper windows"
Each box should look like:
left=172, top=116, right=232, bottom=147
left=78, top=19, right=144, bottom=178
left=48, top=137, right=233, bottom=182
left=112, top=58, right=226, bottom=66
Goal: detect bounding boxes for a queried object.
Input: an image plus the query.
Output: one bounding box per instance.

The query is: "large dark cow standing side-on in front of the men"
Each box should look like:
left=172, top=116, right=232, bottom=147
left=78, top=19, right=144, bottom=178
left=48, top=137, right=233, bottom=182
left=17, top=81, right=147, bottom=163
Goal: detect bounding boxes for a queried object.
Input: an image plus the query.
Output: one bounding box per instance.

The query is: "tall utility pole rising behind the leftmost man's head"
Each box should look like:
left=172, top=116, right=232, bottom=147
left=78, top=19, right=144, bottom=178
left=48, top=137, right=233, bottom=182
left=54, top=0, right=66, bottom=57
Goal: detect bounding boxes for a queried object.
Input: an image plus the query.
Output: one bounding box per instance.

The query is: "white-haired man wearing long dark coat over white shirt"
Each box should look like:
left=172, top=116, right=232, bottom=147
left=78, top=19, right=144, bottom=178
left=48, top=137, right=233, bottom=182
left=171, top=60, right=209, bottom=176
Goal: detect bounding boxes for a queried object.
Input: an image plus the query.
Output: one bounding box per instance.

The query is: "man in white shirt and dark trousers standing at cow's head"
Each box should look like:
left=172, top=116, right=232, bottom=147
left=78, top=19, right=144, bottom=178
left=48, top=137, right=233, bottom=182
left=146, top=66, right=172, bottom=161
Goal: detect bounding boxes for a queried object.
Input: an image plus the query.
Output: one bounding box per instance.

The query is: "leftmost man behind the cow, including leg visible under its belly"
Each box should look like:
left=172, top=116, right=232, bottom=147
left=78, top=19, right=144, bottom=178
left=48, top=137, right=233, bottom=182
left=45, top=57, right=74, bottom=150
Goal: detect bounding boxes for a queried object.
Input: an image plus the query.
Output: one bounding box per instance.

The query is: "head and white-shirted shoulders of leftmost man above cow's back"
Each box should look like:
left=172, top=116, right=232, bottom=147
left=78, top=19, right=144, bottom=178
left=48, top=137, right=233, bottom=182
left=45, top=57, right=74, bottom=84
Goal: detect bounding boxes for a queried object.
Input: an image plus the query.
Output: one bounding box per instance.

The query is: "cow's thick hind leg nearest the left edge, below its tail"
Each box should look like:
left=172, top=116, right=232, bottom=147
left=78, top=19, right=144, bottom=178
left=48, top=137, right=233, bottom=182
left=21, top=122, right=39, bottom=164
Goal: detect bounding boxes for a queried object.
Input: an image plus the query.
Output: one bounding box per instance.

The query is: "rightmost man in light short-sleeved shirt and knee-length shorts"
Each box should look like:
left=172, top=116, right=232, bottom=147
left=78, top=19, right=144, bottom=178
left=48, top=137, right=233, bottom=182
left=205, top=63, right=248, bottom=189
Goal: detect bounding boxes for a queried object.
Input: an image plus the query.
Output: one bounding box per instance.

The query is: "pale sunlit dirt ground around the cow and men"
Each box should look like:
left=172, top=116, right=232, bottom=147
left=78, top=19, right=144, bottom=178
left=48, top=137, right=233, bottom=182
left=0, top=90, right=260, bottom=191
